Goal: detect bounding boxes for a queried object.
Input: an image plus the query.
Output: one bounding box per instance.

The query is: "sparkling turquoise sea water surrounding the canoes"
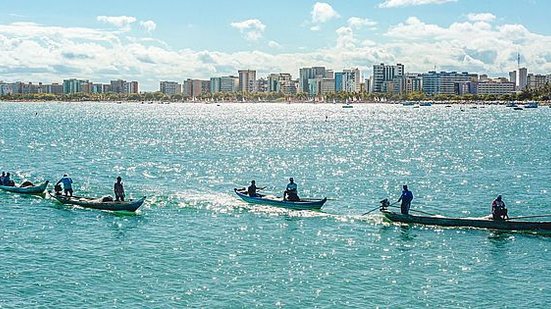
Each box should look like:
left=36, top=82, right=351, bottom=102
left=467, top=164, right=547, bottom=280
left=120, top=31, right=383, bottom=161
left=0, top=102, right=551, bottom=308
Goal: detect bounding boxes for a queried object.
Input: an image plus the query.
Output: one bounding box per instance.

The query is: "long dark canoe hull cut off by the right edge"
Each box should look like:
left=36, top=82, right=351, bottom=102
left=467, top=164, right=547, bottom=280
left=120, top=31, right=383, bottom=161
left=381, top=210, right=551, bottom=231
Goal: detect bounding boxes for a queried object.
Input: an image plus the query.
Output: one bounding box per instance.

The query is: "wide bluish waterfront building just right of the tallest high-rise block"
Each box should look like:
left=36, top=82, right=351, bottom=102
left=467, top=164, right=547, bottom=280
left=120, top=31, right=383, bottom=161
left=422, top=71, right=478, bottom=95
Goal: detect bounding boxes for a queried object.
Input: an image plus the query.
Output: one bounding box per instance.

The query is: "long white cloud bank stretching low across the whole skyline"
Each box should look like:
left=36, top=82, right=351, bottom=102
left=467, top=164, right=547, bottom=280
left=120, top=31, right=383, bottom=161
left=0, top=16, right=551, bottom=90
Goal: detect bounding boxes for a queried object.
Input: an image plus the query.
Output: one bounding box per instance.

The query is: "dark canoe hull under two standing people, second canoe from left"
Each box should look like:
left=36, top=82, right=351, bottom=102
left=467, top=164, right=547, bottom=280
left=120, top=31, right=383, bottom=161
left=48, top=192, right=145, bottom=212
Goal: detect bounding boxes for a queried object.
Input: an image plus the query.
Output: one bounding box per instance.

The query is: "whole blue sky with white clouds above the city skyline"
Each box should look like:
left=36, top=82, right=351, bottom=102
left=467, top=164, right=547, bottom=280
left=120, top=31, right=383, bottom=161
left=0, top=0, right=551, bottom=91
